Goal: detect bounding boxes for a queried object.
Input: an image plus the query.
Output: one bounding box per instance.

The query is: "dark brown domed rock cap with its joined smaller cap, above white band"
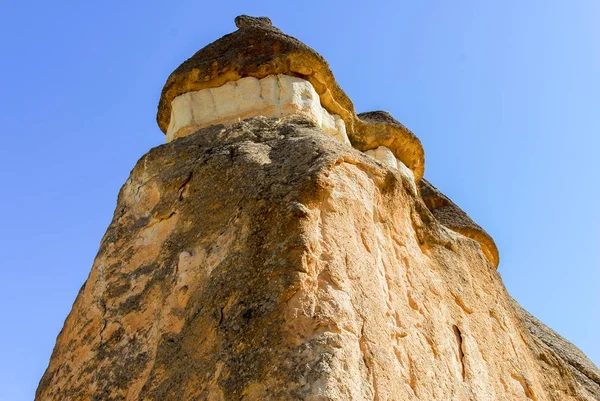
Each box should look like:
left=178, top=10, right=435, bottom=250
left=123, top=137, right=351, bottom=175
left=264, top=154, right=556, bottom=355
left=157, top=15, right=425, bottom=181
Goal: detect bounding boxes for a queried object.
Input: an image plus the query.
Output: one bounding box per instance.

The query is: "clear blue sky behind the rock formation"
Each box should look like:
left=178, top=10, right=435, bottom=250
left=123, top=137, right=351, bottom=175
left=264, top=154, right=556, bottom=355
left=0, top=0, right=600, bottom=401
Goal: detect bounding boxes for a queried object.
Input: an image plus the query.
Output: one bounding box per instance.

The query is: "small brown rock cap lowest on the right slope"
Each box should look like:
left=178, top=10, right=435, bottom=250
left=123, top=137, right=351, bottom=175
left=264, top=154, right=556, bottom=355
left=419, top=178, right=500, bottom=268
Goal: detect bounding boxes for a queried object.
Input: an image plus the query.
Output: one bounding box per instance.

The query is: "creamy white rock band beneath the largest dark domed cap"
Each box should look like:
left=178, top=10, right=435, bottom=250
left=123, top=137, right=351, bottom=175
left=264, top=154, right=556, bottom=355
left=167, top=74, right=350, bottom=144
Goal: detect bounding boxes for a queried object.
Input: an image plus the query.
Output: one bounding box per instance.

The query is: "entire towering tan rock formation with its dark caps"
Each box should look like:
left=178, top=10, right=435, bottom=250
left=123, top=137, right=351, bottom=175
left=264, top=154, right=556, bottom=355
left=36, top=16, right=600, bottom=401
